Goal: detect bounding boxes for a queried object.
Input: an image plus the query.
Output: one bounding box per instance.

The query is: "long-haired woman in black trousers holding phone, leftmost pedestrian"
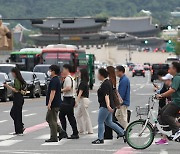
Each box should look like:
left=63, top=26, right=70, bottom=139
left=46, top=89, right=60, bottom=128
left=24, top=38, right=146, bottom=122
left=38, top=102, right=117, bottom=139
left=4, top=67, right=26, bottom=135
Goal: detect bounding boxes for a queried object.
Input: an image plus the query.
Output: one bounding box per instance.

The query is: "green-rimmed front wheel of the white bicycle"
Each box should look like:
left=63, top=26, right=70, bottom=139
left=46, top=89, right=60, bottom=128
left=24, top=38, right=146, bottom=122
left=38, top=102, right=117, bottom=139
left=125, top=120, right=154, bottom=149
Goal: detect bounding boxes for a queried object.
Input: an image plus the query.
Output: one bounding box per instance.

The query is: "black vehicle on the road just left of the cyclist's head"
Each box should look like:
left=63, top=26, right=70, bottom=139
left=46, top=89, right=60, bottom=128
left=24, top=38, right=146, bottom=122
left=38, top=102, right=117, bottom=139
left=151, top=64, right=169, bottom=82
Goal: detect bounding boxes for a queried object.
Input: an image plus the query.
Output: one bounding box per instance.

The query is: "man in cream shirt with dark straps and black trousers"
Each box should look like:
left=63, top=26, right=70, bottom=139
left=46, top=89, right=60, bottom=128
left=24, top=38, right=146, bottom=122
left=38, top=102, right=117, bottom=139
left=59, top=64, right=79, bottom=139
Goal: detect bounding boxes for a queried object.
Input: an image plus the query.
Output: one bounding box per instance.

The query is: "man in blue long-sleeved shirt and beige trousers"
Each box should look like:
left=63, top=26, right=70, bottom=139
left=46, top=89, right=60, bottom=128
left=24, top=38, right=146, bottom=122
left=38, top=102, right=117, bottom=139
left=115, top=66, right=130, bottom=130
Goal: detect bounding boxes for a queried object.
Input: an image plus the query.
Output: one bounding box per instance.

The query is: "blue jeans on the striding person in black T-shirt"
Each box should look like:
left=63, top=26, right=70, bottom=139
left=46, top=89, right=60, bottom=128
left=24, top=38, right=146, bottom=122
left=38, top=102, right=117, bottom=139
left=98, top=107, right=124, bottom=140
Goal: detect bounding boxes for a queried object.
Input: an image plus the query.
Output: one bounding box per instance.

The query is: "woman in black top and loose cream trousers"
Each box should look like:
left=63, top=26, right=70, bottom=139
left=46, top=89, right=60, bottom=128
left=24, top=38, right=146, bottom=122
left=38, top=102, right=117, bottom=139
left=76, top=69, right=93, bottom=134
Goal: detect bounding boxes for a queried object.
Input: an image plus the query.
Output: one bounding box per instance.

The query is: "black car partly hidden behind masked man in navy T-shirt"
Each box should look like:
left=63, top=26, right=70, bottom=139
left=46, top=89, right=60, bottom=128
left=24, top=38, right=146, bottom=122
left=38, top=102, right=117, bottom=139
left=34, top=72, right=49, bottom=96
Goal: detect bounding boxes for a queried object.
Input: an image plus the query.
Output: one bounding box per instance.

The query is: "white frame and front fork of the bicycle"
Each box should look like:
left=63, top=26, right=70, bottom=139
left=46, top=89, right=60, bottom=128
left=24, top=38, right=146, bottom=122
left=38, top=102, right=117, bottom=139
left=139, top=96, right=172, bottom=136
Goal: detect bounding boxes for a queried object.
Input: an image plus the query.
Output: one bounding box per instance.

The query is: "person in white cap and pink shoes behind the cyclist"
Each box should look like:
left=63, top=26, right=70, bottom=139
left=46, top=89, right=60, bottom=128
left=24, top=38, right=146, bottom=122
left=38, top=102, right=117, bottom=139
left=155, top=73, right=173, bottom=145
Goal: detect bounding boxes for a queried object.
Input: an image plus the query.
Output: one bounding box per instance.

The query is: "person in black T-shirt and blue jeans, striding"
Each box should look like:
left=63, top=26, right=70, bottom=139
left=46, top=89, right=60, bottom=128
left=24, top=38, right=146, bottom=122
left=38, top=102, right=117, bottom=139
left=92, top=68, right=124, bottom=144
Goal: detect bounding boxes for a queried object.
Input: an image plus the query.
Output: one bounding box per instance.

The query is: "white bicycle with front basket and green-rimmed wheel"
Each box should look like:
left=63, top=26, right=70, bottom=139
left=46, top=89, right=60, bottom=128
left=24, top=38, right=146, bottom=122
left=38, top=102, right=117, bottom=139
left=125, top=96, right=180, bottom=150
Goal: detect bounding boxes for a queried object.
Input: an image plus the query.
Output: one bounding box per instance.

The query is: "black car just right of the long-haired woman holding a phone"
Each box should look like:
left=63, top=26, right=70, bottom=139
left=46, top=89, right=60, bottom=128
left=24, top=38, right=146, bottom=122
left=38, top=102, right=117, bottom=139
left=21, top=71, right=41, bottom=98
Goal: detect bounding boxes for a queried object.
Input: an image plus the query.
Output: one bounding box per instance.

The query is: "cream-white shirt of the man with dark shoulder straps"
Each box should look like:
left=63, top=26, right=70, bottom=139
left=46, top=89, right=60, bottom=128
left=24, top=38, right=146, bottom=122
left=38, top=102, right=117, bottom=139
left=63, top=75, right=76, bottom=97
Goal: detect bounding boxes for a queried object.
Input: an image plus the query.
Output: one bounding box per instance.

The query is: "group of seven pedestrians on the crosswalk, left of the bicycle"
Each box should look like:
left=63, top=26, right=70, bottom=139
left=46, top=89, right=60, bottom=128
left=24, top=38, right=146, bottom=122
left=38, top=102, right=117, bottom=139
left=4, top=64, right=130, bottom=144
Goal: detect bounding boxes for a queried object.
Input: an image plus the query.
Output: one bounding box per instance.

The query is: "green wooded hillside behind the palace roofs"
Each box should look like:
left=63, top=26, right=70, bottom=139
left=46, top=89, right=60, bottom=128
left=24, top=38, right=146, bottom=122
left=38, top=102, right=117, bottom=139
left=0, top=0, right=180, bottom=23
